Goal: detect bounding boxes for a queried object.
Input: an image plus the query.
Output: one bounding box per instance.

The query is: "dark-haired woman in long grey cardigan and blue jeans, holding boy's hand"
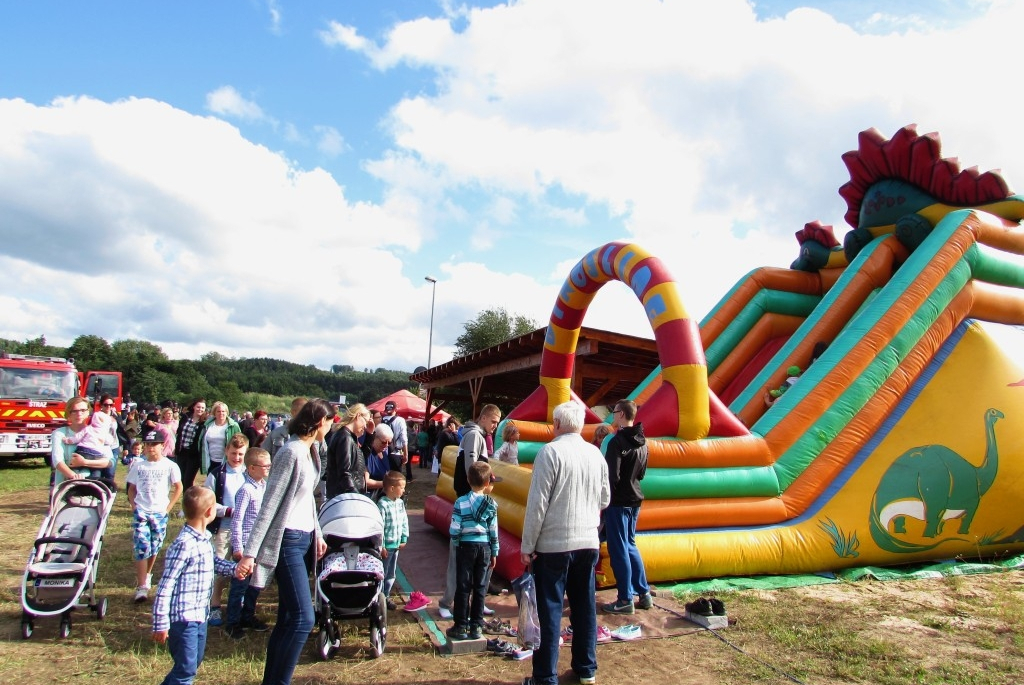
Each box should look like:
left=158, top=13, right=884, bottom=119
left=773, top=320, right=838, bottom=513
left=236, top=399, right=335, bottom=685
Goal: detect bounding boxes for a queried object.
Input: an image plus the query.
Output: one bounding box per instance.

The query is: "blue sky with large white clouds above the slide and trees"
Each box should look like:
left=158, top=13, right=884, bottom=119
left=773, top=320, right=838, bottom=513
left=0, top=0, right=1024, bottom=370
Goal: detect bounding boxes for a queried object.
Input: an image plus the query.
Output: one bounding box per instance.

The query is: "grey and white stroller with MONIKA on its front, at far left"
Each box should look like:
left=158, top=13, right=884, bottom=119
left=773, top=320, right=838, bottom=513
left=22, top=479, right=116, bottom=639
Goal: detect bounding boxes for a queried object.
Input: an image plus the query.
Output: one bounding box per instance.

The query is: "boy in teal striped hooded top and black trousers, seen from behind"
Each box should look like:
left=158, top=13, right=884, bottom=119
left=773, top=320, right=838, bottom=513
left=445, top=461, right=501, bottom=640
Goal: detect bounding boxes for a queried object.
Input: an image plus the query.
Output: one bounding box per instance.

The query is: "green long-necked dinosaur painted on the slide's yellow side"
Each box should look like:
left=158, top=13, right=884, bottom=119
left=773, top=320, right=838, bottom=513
left=870, top=409, right=1005, bottom=553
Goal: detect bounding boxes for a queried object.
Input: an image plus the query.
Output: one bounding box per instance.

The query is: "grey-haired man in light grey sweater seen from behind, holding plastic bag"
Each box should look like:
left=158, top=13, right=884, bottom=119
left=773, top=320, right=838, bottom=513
left=520, top=401, right=610, bottom=685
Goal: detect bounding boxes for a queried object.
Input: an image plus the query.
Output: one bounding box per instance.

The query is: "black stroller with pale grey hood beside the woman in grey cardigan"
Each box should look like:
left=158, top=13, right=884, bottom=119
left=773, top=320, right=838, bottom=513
left=313, top=493, right=387, bottom=659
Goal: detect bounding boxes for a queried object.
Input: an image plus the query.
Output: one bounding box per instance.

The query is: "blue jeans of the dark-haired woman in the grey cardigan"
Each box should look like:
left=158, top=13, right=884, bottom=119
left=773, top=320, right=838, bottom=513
left=263, top=528, right=315, bottom=685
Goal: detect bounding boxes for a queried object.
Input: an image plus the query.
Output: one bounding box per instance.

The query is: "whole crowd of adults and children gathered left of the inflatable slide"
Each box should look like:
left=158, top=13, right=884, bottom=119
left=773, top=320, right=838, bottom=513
left=44, top=395, right=652, bottom=685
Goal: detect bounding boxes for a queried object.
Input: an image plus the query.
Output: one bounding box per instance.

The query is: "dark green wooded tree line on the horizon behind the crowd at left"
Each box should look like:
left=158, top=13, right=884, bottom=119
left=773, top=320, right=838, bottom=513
left=0, top=335, right=416, bottom=410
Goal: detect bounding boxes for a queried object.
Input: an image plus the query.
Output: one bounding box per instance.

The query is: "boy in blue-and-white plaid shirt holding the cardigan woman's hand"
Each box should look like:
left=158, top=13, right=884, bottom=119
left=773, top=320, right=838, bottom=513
left=153, top=486, right=234, bottom=685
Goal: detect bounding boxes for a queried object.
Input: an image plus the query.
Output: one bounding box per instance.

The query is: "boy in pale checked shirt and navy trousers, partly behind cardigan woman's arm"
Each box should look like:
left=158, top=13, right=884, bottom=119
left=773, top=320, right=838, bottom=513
left=224, top=447, right=270, bottom=640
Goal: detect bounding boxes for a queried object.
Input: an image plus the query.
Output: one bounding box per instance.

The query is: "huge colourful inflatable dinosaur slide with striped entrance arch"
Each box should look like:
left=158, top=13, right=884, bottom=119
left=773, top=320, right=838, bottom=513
left=425, top=126, right=1024, bottom=585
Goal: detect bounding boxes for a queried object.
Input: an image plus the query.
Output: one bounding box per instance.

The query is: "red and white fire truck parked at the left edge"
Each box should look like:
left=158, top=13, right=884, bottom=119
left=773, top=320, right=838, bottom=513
left=0, top=351, right=122, bottom=459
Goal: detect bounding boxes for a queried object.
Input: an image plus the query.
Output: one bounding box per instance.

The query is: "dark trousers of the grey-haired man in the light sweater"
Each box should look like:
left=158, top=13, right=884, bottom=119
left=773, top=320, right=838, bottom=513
left=534, top=550, right=598, bottom=685
